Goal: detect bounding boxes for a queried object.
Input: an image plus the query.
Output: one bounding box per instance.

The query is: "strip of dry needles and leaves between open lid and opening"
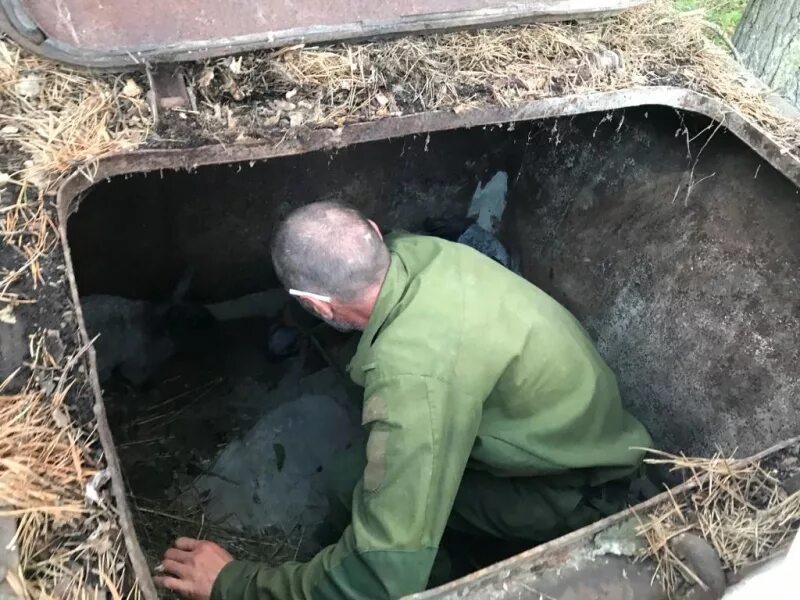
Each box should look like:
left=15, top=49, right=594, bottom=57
left=191, top=0, right=800, bottom=157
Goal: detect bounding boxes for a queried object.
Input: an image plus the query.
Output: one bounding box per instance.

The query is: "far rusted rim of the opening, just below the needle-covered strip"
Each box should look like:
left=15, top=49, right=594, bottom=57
left=56, top=87, right=800, bottom=198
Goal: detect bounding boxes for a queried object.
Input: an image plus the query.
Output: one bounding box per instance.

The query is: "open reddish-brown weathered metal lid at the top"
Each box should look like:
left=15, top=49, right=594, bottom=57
left=0, top=0, right=646, bottom=67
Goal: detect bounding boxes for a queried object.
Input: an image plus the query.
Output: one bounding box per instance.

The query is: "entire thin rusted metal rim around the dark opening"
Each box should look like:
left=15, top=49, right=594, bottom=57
left=56, top=87, right=800, bottom=600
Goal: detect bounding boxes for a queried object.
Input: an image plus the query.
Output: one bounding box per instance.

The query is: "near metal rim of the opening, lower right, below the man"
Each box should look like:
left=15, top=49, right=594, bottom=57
left=401, top=436, right=800, bottom=600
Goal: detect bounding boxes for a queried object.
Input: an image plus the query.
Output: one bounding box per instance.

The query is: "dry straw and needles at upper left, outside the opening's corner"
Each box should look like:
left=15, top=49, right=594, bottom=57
left=0, top=35, right=150, bottom=304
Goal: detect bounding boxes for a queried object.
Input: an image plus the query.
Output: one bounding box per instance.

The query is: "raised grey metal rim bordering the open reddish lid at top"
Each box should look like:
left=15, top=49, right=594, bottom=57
left=0, top=0, right=649, bottom=69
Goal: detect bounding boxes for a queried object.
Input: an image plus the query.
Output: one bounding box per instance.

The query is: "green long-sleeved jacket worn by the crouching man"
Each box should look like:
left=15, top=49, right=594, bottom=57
left=212, top=234, right=650, bottom=600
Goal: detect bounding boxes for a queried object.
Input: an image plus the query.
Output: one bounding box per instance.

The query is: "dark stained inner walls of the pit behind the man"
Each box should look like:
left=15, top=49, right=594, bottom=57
left=70, top=107, right=800, bottom=454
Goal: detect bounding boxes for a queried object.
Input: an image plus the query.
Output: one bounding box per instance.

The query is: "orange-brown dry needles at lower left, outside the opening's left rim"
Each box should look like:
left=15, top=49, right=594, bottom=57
left=0, top=336, right=138, bottom=600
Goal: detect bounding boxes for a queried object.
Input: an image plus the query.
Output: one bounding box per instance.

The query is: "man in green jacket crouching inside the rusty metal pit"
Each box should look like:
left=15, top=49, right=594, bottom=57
left=155, top=202, right=651, bottom=600
